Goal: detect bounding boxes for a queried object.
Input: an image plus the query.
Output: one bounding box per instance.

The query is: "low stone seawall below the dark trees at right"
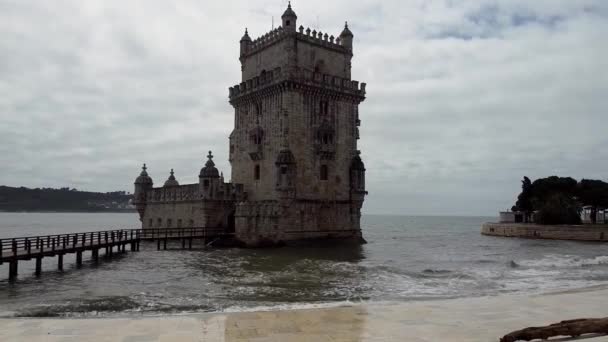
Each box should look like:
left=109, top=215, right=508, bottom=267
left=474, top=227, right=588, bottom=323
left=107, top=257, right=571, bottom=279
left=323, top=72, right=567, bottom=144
left=481, top=223, right=608, bottom=242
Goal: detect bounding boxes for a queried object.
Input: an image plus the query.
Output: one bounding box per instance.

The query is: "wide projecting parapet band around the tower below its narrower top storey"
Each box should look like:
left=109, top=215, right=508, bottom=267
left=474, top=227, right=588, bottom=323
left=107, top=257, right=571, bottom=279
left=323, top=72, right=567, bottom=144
left=228, top=68, right=366, bottom=102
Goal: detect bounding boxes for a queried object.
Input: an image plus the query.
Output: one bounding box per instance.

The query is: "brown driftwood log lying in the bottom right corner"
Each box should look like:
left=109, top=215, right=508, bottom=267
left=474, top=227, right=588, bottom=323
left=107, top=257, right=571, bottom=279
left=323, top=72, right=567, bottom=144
left=500, top=317, right=608, bottom=342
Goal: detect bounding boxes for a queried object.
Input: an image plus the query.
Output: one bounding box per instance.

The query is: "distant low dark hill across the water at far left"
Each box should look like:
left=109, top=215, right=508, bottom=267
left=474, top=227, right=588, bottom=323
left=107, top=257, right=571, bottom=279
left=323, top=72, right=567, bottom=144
left=0, top=186, right=135, bottom=212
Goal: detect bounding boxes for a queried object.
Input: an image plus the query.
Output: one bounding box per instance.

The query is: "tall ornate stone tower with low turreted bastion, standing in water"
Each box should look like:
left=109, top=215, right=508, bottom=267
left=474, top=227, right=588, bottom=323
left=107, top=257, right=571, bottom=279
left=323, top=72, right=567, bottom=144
left=134, top=4, right=367, bottom=247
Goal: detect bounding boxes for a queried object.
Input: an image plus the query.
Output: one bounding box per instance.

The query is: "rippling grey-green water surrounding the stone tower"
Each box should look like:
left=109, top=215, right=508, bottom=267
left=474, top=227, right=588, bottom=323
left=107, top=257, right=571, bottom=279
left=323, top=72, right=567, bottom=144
left=0, top=213, right=608, bottom=317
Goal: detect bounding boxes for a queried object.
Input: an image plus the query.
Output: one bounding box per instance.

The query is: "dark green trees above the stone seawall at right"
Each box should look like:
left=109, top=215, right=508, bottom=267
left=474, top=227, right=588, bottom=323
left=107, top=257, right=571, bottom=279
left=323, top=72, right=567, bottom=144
left=512, top=176, right=608, bottom=224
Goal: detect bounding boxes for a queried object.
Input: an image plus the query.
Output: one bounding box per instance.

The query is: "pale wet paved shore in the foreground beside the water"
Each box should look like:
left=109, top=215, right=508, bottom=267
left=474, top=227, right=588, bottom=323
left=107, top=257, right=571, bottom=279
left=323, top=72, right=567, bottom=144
left=0, top=285, right=608, bottom=342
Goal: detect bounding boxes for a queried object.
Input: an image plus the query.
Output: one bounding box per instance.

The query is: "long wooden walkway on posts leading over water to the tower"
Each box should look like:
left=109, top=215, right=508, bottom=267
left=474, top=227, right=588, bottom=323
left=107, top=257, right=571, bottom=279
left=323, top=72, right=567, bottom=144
left=0, top=228, right=233, bottom=279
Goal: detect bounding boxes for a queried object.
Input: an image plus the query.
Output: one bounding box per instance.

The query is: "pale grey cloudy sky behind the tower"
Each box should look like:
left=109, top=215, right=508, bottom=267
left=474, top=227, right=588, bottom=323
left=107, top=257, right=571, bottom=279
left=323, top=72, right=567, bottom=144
left=0, top=0, right=608, bottom=215
